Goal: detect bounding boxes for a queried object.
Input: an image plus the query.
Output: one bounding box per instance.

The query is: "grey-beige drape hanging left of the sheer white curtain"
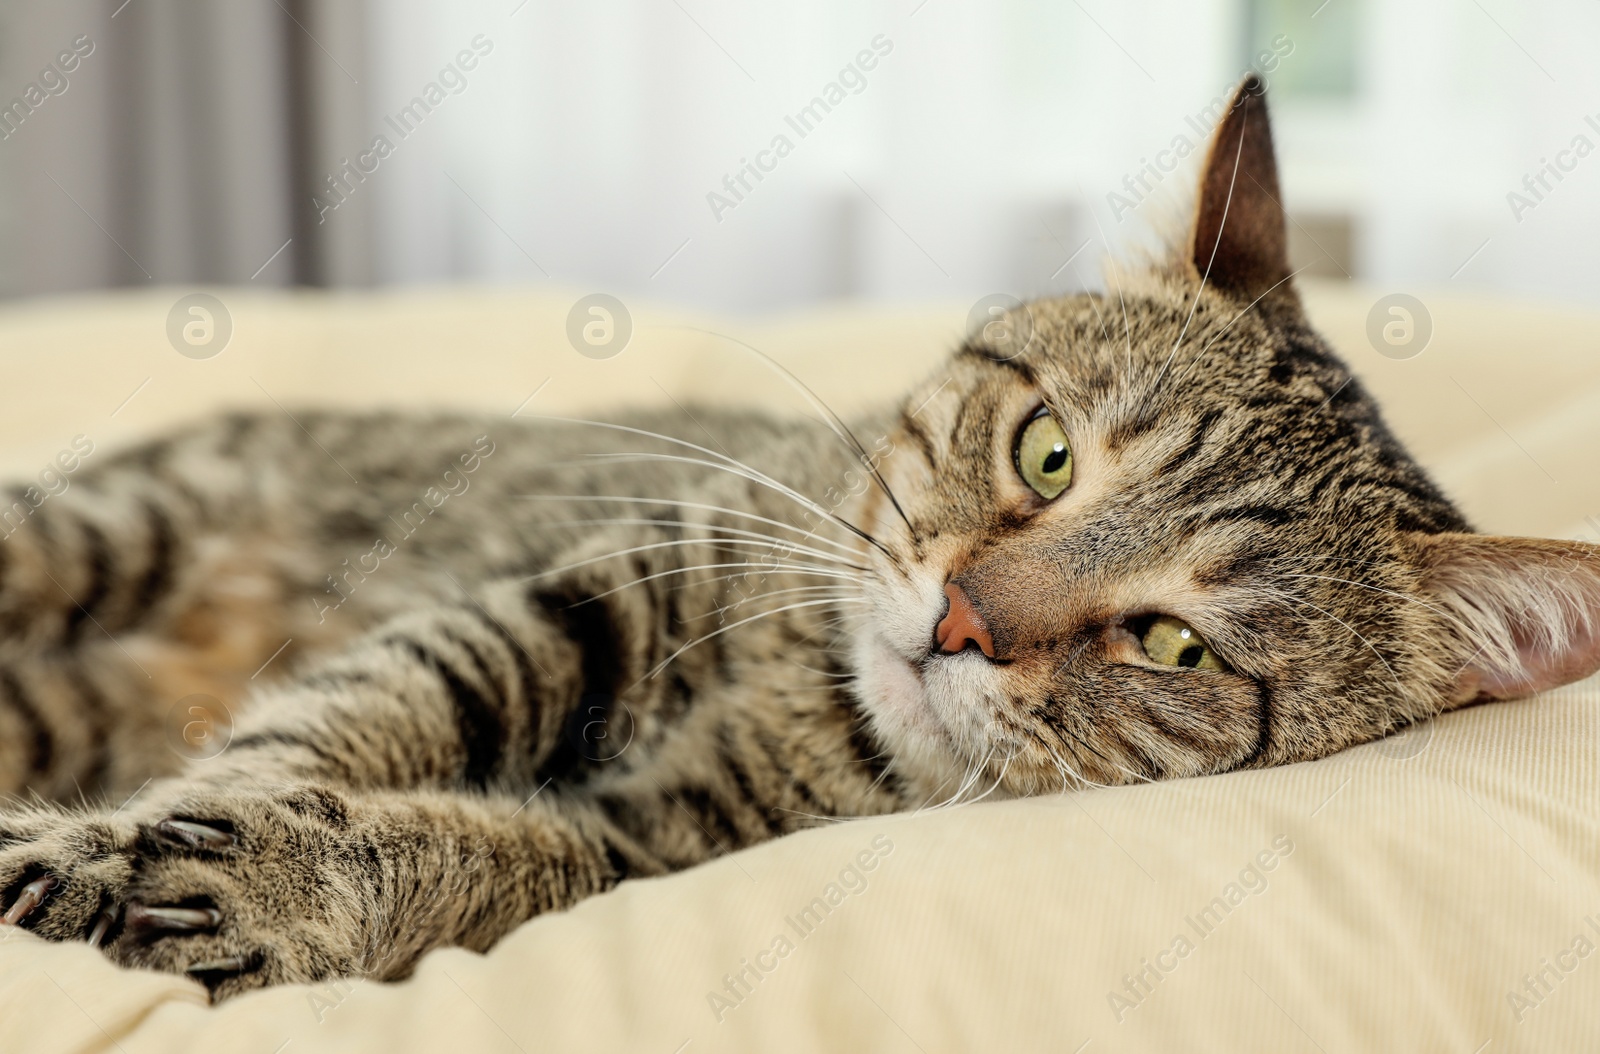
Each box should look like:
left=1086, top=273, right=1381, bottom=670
left=0, top=0, right=371, bottom=296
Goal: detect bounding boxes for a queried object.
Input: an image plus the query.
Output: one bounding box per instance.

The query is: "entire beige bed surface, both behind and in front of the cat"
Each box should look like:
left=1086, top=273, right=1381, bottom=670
left=0, top=285, right=1600, bottom=1054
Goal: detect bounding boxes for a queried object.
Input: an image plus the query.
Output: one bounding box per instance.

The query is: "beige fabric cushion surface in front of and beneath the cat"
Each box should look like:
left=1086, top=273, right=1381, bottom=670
left=0, top=681, right=1600, bottom=1054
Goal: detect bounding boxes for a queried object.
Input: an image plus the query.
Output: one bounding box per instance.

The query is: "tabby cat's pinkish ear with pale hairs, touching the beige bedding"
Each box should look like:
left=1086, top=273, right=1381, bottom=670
left=1416, top=534, right=1600, bottom=705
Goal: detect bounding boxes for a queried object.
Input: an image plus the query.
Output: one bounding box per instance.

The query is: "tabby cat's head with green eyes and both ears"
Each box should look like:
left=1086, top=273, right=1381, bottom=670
left=853, top=80, right=1600, bottom=792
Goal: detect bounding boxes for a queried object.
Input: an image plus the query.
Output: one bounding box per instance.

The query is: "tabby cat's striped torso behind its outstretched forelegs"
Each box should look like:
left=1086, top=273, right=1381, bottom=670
left=0, top=408, right=886, bottom=812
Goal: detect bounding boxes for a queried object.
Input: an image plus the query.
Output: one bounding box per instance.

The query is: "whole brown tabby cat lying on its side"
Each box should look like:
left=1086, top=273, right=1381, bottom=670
left=0, top=78, right=1600, bottom=1000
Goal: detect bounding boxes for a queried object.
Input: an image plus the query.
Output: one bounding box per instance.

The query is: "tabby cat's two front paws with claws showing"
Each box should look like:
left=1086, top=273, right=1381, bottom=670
left=0, top=789, right=371, bottom=998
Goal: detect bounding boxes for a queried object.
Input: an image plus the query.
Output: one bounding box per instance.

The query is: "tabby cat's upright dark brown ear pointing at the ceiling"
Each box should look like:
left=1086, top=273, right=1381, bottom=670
left=1189, top=75, right=1296, bottom=304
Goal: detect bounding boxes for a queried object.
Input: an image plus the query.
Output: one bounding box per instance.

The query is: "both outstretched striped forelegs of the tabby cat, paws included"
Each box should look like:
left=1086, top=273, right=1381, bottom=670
left=0, top=571, right=656, bottom=990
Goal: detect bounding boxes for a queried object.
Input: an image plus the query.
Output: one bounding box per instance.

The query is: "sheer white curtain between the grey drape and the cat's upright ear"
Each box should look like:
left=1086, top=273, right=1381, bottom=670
left=360, top=0, right=1240, bottom=309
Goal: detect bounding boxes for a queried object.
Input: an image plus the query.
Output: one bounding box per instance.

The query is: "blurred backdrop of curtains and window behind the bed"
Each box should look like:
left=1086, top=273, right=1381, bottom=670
left=0, top=0, right=1600, bottom=310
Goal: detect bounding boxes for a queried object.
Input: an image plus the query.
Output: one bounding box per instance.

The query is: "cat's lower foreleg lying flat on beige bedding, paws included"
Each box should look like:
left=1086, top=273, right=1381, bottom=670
left=0, top=787, right=659, bottom=998
